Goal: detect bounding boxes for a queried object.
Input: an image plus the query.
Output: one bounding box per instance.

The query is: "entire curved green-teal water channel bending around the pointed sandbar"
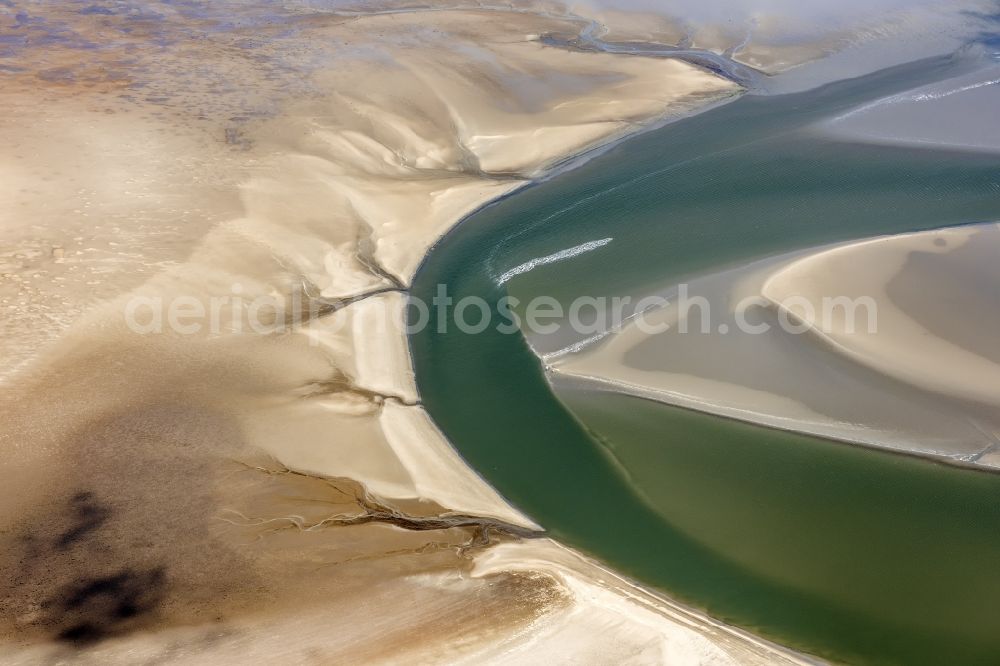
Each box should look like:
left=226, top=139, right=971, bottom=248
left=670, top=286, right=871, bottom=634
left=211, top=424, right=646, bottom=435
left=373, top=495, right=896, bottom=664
left=411, top=54, right=1000, bottom=664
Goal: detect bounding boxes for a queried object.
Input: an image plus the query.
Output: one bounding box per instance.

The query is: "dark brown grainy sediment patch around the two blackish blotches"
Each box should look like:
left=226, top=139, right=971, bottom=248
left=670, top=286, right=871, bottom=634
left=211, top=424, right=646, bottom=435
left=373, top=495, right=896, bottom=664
left=0, top=404, right=264, bottom=643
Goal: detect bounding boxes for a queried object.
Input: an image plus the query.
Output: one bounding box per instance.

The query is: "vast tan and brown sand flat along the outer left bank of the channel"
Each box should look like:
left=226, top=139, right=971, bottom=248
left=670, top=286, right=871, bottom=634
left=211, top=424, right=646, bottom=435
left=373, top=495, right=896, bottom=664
left=0, top=4, right=797, bottom=664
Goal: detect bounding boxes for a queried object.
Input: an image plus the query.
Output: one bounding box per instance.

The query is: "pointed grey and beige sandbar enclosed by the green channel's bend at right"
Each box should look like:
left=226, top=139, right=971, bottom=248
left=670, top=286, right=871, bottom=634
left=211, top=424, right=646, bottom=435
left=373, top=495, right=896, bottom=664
left=553, top=225, right=1000, bottom=465
